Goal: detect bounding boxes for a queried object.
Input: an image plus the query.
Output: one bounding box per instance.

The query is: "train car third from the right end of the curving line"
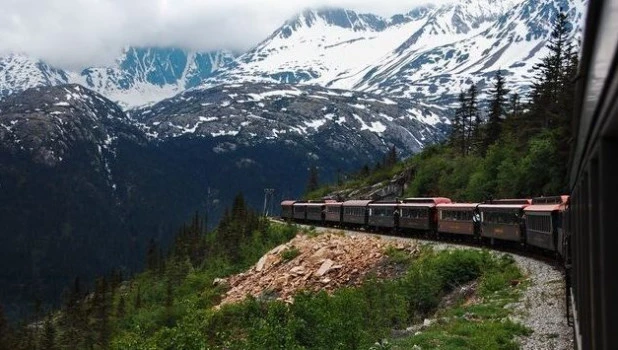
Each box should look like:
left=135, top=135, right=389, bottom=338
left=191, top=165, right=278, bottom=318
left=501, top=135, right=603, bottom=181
left=436, top=203, right=480, bottom=236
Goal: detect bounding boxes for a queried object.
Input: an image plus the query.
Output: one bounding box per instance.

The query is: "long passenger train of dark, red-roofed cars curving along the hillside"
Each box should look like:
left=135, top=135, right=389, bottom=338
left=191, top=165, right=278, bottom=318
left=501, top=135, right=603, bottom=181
left=281, top=195, right=569, bottom=257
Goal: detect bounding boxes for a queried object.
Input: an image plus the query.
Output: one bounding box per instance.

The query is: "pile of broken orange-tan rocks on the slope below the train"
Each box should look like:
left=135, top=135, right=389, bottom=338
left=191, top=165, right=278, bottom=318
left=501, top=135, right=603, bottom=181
left=221, top=233, right=418, bottom=305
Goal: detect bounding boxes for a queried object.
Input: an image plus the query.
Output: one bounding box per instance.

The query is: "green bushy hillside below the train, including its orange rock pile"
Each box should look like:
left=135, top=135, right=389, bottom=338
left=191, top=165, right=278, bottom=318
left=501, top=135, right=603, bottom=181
left=0, top=198, right=540, bottom=349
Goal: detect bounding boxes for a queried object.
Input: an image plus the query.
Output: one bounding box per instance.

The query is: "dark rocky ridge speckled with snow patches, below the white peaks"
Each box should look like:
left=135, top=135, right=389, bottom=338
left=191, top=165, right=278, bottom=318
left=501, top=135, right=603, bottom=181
left=130, top=83, right=449, bottom=156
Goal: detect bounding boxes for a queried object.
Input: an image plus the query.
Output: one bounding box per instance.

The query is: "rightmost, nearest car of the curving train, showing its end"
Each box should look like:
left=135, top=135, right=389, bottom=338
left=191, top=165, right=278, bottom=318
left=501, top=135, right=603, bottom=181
left=524, top=196, right=569, bottom=254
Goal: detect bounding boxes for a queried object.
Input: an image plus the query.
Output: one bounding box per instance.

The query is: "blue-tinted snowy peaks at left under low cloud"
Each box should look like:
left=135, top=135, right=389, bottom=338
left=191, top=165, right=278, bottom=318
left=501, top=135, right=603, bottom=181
left=0, top=48, right=234, bottom=108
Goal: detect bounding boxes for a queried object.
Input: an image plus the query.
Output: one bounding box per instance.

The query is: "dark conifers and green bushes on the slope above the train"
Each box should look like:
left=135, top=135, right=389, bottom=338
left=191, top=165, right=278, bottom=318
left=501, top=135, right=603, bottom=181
left=307, top=10, right=578, bottom=201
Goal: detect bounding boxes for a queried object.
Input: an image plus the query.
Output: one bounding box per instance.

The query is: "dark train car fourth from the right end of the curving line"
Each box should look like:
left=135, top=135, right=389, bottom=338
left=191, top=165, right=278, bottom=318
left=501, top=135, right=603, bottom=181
left=398, top=197, right=451, bottom=232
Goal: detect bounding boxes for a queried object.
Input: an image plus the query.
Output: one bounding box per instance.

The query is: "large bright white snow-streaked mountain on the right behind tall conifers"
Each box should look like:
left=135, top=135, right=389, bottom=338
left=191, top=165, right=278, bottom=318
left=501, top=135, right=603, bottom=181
left=209, top=0, right=585, bottom=104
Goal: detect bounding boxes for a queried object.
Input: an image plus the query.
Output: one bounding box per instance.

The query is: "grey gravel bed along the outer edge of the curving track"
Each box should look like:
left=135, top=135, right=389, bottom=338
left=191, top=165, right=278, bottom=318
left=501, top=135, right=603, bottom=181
left=308, top=227, right=575, bottom=350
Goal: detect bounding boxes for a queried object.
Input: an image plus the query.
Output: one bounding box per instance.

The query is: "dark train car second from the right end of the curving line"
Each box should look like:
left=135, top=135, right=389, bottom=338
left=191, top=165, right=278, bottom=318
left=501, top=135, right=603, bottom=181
left=479, top=199, right=531, bottom=243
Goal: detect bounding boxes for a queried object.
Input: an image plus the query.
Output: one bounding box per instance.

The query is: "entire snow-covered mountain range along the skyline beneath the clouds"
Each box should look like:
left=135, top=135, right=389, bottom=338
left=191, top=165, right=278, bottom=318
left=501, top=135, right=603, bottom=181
left=0, top=0, right=586, bottom=108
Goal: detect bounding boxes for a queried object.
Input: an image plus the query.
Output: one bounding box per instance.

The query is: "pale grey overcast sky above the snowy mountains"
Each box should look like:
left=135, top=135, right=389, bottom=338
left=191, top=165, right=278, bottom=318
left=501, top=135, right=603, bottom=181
left=0, top=0, right=448, bottom=69
